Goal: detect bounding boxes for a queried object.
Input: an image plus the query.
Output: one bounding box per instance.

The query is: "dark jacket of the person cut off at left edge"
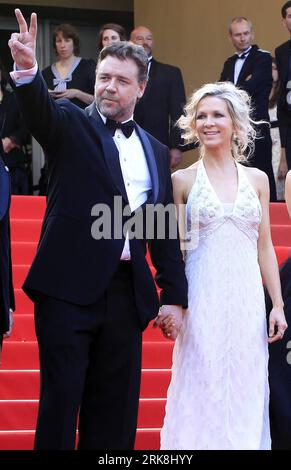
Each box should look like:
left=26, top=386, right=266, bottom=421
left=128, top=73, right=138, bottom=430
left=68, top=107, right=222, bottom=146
left=0, top=157, right=15, bottom=338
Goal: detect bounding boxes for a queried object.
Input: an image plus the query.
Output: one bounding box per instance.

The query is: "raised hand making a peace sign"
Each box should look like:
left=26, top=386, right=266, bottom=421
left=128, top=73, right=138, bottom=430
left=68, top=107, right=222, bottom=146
left=8, top=8, right=37, bottom=70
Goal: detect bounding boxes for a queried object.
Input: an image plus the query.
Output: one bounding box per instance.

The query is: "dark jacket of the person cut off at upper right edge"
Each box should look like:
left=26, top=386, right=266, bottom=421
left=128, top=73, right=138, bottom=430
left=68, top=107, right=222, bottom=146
left=275, top=41, right=291, bottom=147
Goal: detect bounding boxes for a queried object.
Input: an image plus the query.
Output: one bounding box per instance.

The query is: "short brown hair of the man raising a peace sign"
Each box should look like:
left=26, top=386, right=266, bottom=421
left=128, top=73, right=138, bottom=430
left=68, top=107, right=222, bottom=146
left=97, top=41, right=148, bottom=83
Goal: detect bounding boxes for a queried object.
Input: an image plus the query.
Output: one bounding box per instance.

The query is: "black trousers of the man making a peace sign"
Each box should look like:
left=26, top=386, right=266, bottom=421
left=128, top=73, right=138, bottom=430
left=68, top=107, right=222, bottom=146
left=35, top=262, right=142, bottom=450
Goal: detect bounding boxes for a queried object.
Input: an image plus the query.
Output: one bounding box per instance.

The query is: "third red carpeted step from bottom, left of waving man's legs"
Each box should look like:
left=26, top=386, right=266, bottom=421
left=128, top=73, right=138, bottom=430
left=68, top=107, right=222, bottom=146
left=0, top=369, right=39, bottom=400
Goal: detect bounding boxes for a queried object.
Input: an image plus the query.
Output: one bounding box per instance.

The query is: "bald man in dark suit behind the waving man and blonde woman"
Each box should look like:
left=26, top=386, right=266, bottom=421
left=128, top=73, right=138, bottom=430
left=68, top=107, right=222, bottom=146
left=130, top=26, right=186, bottom=168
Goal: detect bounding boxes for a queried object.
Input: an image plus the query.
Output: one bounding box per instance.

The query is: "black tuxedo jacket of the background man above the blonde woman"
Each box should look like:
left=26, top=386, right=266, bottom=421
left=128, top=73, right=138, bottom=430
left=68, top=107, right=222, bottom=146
left=220, top=45, right=272, bottom=121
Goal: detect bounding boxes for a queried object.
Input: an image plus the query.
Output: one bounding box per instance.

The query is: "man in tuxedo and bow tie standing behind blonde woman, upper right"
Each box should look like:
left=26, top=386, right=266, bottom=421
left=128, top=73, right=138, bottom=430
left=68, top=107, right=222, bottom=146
left=220, top=17, right=277, bottom=201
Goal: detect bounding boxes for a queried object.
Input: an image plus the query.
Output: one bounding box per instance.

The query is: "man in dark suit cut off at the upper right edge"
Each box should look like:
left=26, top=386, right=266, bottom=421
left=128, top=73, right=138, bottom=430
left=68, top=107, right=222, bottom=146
left=275, top=1, right=291, bottom=173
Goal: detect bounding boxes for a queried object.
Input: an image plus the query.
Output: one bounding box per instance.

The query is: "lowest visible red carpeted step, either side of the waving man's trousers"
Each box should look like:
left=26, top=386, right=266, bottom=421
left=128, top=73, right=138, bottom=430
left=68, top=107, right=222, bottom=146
left=0, top=429, right=160, bottom=450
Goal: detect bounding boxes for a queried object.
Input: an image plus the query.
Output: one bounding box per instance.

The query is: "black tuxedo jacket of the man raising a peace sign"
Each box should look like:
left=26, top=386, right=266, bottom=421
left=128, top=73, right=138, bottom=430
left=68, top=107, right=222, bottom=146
left=16, top=73, right=187, bottom=327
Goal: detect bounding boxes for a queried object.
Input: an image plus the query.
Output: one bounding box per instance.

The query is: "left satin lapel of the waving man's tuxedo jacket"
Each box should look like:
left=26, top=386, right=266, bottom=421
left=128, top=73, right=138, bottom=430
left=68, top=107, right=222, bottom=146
left=86, top=103, right=128, bottom=204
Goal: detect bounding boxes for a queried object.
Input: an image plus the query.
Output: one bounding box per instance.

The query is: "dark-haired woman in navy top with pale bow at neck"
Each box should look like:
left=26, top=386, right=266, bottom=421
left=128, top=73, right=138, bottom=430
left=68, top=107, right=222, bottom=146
left=42, top=24, right=96, bottom=108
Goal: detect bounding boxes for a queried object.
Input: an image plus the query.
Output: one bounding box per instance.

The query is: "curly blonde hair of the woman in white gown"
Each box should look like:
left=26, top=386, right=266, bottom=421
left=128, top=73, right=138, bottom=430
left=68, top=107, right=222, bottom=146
left=177, top=82, right=265, bottom=162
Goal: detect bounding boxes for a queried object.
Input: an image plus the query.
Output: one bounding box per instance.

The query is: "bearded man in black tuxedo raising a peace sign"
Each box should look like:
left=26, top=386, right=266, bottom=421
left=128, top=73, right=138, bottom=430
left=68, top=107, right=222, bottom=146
left=9, top=9, right=187, bottom=449
